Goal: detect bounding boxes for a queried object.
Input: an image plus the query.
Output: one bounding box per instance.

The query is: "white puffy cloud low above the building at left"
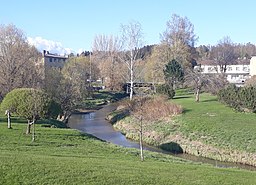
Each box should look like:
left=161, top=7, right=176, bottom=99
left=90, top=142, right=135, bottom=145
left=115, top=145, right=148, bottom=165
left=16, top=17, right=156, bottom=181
left=28, top=37, right=74, bottom=55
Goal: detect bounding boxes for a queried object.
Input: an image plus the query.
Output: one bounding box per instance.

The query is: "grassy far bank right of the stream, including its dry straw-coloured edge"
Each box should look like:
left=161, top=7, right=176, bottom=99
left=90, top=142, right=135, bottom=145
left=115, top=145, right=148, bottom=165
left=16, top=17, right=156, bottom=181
left=110, top=94, right=256, bottom=166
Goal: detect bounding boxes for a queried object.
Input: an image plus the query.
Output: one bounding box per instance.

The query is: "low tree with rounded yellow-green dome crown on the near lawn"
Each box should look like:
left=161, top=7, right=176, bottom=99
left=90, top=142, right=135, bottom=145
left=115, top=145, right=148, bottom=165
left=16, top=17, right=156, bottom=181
left=1, top=88, right=52, bottom=140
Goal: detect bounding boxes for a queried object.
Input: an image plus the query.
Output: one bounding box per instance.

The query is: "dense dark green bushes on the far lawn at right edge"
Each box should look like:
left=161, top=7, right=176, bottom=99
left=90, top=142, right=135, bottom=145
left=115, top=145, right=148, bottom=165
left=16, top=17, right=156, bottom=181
left=218, top=85, right=256, bottom=112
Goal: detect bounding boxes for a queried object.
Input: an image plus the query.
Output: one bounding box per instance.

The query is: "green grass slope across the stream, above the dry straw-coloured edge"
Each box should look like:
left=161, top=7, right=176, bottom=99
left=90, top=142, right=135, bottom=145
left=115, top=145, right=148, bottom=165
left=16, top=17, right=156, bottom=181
left=173, top=94, right=256, bottom=153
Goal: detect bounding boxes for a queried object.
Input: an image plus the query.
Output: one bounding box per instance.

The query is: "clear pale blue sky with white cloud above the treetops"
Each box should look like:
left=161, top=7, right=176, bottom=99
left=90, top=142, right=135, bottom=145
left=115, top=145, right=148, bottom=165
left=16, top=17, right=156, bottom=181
left=0, top=0, right=256, bottom=54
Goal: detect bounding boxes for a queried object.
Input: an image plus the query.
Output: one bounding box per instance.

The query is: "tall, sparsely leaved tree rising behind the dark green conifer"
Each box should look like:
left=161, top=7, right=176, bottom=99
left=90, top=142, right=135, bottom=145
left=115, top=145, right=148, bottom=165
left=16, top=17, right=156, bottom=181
left=162, top=14, right=198, bottom=67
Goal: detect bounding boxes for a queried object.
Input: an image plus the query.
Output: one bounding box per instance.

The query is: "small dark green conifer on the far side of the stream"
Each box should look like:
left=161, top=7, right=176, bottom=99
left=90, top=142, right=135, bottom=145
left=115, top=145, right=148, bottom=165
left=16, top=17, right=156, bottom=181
left=164, top=59, right=184, bottom=90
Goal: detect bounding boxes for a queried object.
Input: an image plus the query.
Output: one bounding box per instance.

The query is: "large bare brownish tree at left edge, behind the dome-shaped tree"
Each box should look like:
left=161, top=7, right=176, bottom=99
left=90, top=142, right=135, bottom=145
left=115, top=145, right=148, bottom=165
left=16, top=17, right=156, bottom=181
left=0, top=25, right=40, bottom=97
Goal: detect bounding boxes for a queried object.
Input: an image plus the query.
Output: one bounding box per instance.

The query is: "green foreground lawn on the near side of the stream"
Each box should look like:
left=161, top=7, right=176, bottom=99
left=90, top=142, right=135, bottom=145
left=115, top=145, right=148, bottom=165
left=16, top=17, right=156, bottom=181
left=0, top=123, right=256, bottom=185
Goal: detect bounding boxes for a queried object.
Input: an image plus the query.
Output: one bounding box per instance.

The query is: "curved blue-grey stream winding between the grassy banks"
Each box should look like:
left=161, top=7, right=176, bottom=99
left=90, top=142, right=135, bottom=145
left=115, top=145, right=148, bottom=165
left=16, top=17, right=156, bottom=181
left=68, top=104, right=256, bottom=171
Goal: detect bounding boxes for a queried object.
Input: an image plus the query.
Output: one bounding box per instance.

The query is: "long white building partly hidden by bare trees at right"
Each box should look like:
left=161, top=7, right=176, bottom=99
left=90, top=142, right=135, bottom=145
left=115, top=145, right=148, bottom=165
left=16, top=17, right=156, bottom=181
left=196, top=57, right=256, bottom=86
